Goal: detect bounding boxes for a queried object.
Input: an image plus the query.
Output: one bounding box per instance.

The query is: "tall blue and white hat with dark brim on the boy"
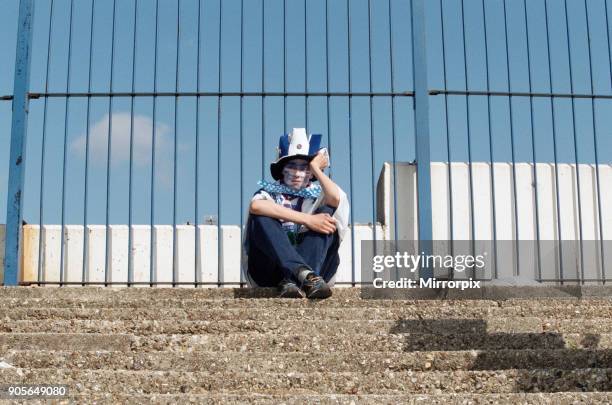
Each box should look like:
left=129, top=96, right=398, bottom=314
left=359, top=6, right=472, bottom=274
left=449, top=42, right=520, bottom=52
left=270, top=128, right=323, bottom=180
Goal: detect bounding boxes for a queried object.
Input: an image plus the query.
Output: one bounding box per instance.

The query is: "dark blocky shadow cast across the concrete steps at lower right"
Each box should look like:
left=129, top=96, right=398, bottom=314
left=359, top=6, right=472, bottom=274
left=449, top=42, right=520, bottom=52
left=389, top=319, right=612, bottom=392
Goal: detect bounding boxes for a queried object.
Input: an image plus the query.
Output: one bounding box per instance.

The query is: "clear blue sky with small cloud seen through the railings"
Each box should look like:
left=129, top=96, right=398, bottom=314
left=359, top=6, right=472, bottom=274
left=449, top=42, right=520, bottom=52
left=0, top=0, right=612, bottom=224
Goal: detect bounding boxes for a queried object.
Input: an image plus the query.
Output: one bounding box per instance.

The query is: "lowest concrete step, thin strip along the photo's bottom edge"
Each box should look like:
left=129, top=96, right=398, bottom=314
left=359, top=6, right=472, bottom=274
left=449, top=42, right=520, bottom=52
left=10, top=392, right=612, bottom=405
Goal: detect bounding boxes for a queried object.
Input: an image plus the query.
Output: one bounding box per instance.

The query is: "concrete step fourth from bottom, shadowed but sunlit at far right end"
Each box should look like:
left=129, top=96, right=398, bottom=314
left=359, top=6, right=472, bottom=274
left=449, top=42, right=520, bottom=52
left=0, top=332, right=612, bottom=353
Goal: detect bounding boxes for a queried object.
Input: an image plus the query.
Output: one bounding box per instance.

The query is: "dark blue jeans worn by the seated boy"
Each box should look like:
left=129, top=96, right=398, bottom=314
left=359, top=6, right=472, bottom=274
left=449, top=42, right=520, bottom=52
left=247, top=205, right=340, bottom=287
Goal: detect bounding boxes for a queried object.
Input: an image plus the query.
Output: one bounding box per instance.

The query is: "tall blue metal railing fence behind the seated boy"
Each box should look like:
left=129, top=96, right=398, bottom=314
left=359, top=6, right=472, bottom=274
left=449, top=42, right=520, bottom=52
left=3, top=0, right=612, bottom=285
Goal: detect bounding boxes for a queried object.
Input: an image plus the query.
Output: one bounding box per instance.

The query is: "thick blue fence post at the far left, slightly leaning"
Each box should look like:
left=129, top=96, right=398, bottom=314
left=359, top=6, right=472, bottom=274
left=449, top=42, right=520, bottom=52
left=4, top=0, right=34, bottom=286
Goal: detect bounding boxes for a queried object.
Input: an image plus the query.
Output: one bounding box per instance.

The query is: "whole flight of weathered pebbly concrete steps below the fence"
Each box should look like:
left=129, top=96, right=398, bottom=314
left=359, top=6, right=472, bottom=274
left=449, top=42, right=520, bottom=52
left=0, top=288, right=612, bottom=404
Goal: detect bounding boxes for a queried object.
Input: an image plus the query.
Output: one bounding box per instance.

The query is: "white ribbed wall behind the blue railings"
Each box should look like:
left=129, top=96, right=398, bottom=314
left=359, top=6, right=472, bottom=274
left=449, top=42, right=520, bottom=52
left=0, top=162, right=612, bottom=286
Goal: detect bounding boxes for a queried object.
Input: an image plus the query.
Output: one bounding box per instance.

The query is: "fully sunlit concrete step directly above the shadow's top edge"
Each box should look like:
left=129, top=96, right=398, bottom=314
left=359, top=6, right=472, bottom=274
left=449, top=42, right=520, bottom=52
left=0, top=302, right=612, bottom=321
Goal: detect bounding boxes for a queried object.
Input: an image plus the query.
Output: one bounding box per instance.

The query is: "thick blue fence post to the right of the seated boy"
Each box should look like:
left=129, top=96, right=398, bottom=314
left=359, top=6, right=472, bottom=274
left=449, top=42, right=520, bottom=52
left=412, top=0, right=433, bottom=278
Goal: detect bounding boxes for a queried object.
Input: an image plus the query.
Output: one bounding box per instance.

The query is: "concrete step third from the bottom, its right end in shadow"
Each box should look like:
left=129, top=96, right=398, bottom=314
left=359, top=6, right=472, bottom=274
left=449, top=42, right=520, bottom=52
left=0, top=349, right=612, bottom=373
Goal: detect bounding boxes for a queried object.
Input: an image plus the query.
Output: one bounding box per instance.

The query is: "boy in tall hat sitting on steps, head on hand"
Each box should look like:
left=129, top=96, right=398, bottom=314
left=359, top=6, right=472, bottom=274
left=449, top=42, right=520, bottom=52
left=242, top=128, right=349, bottom=298
